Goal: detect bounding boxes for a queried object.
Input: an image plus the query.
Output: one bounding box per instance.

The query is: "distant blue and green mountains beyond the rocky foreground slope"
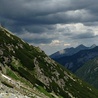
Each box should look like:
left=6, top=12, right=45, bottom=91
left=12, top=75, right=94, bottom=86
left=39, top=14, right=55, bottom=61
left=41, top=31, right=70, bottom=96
left=50, top=44, right=98, bottom=89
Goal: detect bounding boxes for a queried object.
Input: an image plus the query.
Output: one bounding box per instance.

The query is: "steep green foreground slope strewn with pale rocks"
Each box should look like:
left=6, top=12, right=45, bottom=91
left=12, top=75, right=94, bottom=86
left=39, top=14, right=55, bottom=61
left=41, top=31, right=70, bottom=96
left=0, top=27, right=98, bottom=98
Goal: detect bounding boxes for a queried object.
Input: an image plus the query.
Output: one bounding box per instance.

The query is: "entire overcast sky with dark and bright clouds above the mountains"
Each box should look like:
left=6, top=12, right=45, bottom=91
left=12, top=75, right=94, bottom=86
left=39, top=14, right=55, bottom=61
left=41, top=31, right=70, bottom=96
left=0, top=0, right=98, bottom=55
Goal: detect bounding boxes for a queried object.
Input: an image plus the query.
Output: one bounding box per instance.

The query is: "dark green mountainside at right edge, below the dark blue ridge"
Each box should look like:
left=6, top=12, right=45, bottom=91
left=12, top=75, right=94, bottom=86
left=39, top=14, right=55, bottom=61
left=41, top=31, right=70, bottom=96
left=75, top=58, right=98, bottom=88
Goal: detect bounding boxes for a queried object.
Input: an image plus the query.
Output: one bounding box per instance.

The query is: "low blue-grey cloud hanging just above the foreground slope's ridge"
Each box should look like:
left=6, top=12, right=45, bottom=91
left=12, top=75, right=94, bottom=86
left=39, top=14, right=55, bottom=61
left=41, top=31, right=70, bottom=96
left=16, top=31, right=54, bottom=44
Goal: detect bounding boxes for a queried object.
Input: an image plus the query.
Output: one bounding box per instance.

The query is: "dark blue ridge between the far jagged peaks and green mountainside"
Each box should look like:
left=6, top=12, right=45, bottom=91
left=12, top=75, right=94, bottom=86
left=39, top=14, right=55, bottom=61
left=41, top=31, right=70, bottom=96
left=54, top=46, right=98, bottom=72
